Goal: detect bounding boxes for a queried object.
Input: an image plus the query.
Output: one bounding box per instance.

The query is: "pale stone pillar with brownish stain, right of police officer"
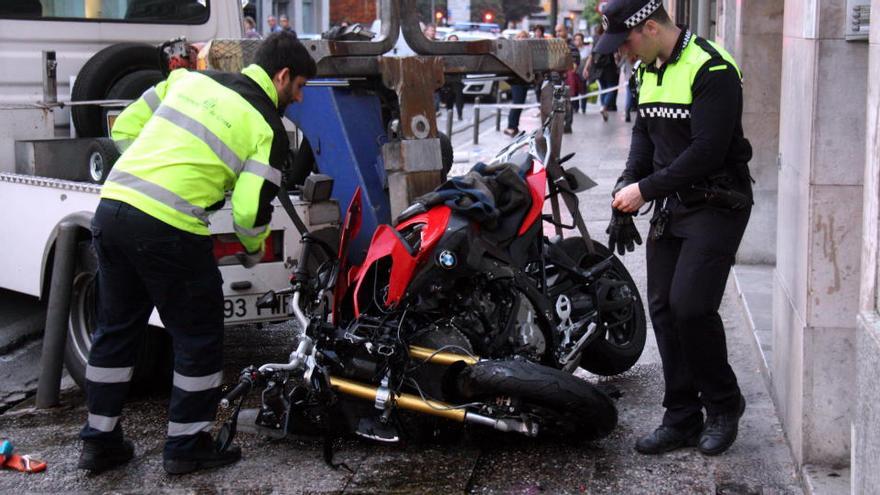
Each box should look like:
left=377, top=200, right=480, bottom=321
left=771, top=0, right=868, bottom=465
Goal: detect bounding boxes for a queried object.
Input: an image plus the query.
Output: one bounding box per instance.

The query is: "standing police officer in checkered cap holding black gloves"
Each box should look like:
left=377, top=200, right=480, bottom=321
left=595, top=0, right=752, bottom=455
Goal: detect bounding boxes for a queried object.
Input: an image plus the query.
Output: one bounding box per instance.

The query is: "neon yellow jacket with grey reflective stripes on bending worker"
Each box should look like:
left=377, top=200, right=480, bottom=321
left=101, top=65, right=289, bottom=252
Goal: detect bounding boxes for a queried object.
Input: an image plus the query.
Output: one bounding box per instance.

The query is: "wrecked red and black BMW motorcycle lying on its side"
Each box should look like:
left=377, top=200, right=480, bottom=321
left=223, top=84, right=645, bottom=450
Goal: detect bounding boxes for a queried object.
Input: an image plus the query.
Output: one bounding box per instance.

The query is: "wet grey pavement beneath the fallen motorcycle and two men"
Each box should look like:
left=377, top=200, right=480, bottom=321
left=0, top=106, right=801, bottom=494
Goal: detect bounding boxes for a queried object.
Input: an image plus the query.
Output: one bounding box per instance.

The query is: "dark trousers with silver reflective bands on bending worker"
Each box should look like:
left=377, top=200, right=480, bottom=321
left=80, top=199, right=223, bottom=457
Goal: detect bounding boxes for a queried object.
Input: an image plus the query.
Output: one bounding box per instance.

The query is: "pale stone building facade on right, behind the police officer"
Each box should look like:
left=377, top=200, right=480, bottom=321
left=696, top=0, right=880, bottom=493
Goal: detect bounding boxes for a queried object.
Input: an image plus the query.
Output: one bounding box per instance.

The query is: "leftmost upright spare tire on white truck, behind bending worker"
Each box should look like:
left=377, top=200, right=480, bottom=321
left=70, top=43, right=160, bottom=137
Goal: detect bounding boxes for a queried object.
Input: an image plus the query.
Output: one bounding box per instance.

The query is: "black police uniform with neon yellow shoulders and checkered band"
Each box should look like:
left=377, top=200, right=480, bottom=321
left=622, top=27, right=752, bottom=429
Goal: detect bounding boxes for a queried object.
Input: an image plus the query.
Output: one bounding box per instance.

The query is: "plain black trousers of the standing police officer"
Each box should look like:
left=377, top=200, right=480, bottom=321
left=647, top=200, right=750, bottom=428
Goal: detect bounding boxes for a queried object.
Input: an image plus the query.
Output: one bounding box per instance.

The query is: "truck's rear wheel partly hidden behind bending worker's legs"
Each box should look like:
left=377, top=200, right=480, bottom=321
left=64, top=241, right=172, bottom=393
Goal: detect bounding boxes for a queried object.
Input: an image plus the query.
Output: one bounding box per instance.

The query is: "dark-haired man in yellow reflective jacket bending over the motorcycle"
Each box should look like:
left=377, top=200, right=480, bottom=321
left=79, top=32, right=316, bottom=474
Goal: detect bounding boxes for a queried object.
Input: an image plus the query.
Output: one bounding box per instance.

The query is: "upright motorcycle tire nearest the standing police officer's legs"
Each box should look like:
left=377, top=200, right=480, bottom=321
left=561, top=237, right=648, bottom=376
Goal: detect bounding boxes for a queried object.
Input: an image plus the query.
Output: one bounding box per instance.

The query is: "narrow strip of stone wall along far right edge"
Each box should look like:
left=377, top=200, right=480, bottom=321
left=851, top=0, right=880, bottom=493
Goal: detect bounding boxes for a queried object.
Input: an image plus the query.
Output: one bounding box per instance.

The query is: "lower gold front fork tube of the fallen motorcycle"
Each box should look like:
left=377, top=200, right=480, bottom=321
left=330, top=376, right=538, bottom=437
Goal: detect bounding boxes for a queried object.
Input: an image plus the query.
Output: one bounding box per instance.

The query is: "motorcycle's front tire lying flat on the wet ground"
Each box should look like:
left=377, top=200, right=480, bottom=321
left=456, top=360, right=617, bottom=441
